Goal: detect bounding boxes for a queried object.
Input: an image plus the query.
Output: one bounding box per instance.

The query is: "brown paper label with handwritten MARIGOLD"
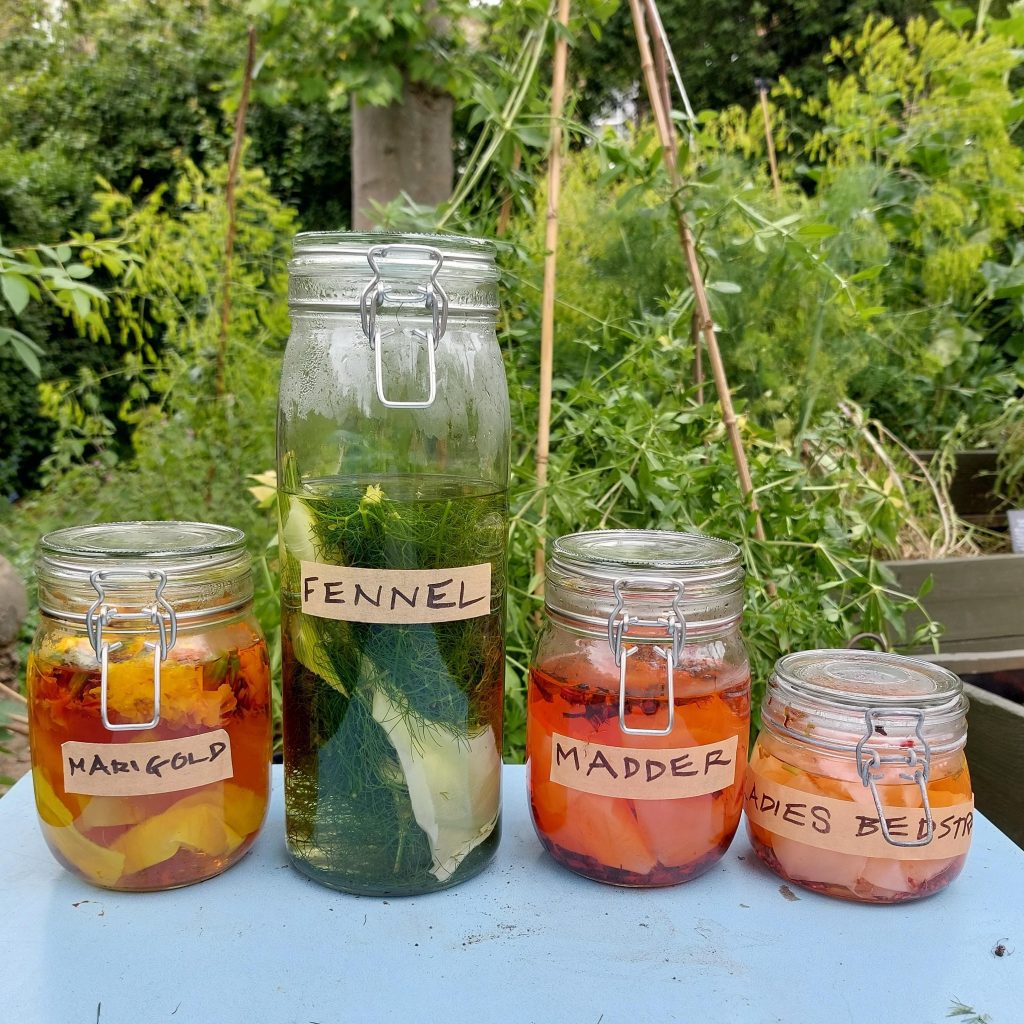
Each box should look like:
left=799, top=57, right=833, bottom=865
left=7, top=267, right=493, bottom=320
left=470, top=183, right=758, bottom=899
left=60, top=729, right=234, bottom=797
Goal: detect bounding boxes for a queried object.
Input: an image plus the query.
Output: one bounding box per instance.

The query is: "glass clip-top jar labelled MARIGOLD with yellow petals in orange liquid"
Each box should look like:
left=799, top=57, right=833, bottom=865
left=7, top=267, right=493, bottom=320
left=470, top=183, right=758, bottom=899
left=28, top=522, right=271, bottom=891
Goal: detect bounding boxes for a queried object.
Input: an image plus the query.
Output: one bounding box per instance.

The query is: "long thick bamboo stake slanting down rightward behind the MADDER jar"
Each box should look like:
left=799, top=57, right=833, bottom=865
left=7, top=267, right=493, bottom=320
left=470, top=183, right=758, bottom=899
left=630, top=0, right=774, bottom=552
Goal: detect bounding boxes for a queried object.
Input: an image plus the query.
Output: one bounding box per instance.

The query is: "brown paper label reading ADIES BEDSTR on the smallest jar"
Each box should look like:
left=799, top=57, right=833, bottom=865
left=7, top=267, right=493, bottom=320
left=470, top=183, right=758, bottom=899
left=743, top=768, right=974, bottom=860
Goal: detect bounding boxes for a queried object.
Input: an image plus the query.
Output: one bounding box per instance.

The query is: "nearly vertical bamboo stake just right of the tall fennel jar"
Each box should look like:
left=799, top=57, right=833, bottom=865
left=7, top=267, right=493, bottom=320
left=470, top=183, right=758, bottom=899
left=534, top=0, right=569, bottom=594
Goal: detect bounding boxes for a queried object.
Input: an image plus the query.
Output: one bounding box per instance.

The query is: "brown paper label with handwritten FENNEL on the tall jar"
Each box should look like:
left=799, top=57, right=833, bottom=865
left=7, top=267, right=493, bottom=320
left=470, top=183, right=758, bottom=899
left=301, top=561, right=490, bottom=624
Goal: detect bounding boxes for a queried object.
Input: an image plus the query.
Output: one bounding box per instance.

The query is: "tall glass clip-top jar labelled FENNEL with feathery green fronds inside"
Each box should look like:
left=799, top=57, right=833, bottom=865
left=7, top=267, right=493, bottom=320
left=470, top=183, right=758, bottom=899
left=278, top=233, right=510, bottom=894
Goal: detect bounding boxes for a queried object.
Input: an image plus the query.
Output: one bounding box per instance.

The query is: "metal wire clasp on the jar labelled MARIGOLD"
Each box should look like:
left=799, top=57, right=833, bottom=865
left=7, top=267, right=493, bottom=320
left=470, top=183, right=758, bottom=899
left=85, top=569, right=178, bottom=732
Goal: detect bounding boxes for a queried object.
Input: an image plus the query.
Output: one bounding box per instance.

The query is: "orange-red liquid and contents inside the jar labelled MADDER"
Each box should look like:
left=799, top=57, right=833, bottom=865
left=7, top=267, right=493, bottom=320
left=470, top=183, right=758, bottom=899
left=526, top=655, right=750, bottom=886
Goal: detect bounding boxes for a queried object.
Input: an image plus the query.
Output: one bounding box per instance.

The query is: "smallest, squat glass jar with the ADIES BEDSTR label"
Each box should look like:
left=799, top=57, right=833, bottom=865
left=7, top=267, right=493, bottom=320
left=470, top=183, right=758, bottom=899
left=743, top=650, right=974, bottom=903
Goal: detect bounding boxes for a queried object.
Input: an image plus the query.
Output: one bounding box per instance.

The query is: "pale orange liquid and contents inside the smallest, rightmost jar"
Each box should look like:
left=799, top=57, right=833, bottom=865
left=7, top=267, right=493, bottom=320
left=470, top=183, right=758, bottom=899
left=746, top=732, right=971, bottom=903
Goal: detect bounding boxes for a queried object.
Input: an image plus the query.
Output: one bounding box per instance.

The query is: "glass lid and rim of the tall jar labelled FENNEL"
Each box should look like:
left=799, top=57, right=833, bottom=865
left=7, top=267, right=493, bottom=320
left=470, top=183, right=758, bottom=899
left=288, top=231, right=498, bottom=315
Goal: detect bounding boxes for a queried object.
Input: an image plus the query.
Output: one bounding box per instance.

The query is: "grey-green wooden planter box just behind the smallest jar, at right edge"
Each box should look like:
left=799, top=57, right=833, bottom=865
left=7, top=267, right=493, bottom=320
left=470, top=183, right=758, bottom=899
left=886, top=554, right=1024, bottom=847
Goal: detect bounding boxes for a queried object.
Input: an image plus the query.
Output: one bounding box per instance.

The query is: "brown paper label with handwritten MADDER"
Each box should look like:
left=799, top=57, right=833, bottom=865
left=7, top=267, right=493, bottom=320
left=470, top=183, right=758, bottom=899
left=551, top=732, right=738, bottom=800
